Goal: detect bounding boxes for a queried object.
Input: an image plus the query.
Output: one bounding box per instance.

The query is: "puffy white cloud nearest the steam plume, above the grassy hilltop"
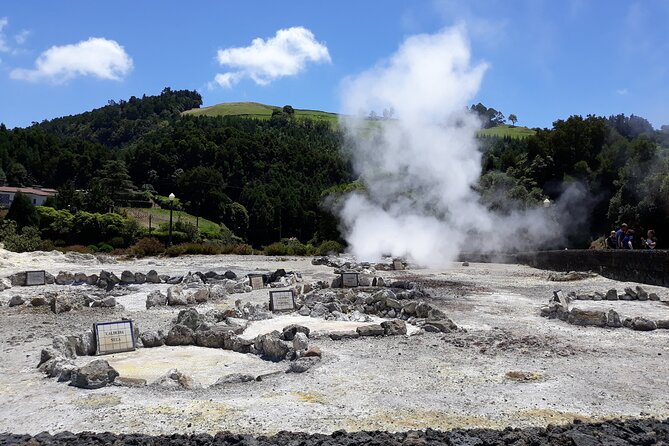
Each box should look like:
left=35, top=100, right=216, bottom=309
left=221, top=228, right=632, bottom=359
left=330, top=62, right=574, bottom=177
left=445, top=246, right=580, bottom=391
left=215, top=26, right=331, bottom=88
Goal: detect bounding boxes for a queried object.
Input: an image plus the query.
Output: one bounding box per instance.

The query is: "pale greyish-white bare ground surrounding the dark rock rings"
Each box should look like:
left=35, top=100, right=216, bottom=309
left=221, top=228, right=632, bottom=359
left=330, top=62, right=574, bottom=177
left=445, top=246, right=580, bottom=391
left=0, top=251, right=669, bottom=444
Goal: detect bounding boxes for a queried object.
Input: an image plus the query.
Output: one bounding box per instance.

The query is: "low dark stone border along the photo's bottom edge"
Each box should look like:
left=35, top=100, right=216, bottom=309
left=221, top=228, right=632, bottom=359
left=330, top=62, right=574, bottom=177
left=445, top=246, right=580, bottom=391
left=0, top=418, right=669, bottom=446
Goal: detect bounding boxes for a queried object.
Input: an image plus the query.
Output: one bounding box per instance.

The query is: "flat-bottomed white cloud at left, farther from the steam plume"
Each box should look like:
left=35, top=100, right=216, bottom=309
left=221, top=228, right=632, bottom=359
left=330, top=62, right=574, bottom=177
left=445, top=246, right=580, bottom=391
left=10, top=37, right=132, bottom=83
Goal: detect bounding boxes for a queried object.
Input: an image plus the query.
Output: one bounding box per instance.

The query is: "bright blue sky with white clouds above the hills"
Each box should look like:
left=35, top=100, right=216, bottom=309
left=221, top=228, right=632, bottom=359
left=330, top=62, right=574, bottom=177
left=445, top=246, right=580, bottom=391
left=0, top=0, right=669, bottom=128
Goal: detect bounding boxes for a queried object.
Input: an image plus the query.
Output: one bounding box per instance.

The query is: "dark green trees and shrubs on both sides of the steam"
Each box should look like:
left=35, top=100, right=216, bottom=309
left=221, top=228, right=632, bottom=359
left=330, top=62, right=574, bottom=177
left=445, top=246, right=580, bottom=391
left=0, top=88, right=669, bottom=255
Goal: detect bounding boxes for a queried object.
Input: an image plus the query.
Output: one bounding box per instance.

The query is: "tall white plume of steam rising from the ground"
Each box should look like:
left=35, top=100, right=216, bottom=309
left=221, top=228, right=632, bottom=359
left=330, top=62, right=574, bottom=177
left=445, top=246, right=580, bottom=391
left=339, top=28, right=576, bottom=266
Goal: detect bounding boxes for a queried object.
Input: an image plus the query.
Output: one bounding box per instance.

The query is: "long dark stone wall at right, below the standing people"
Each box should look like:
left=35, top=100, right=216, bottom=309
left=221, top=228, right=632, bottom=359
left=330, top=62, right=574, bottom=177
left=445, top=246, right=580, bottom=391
left=516, top=249, right=669, bottom=287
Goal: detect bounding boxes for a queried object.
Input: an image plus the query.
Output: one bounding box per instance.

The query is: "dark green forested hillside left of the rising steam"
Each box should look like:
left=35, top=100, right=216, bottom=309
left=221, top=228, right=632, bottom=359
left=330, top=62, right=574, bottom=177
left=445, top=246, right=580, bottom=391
left=0, top=89, right=352, bottom=246
